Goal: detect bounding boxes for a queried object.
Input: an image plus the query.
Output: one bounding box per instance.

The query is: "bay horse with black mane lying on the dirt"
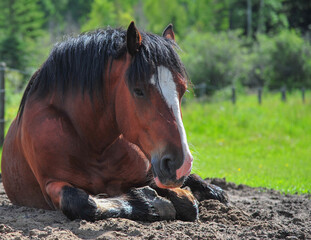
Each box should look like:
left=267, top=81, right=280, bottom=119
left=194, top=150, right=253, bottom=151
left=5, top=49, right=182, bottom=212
left=1, top=22, right=227, bottom=221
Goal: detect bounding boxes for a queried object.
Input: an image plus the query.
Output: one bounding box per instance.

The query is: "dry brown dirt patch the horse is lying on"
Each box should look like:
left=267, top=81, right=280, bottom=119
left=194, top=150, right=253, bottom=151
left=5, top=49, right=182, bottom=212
left=0, top=177, right=311, bottom=240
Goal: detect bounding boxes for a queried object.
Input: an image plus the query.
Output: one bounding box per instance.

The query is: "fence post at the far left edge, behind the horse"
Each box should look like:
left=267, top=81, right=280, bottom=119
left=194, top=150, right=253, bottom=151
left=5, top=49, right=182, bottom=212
left=0, top=62, right=6, bottom=146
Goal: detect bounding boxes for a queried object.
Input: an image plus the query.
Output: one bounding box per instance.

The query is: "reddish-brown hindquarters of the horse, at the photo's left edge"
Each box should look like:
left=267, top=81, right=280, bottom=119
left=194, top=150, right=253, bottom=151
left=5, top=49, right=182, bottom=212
left=1, top=120, right=50, bottom=209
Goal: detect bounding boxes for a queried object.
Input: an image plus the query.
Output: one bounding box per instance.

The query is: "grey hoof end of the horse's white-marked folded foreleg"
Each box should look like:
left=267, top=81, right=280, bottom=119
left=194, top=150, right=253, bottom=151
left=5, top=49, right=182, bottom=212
left=130, top=186, right=176, bottom=221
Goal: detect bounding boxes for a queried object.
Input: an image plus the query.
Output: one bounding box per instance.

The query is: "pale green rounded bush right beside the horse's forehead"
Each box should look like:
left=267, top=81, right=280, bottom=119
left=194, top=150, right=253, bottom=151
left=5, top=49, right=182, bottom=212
left=181, top=32, right=245, bottom=94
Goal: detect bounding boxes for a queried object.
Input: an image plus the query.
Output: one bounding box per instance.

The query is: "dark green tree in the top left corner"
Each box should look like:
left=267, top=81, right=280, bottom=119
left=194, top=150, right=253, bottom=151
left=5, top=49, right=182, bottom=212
left=0, top=0, right=43, bottom=69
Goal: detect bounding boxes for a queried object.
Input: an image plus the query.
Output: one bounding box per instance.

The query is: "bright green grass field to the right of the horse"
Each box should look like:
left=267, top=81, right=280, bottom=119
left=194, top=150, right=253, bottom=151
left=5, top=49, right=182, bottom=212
left=183, top=93, right=311, bottom=193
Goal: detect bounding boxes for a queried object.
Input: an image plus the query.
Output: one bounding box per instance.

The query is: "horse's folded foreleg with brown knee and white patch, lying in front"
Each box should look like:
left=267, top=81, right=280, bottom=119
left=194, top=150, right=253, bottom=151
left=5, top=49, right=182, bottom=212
left=46, top=182, right=176, bottom=221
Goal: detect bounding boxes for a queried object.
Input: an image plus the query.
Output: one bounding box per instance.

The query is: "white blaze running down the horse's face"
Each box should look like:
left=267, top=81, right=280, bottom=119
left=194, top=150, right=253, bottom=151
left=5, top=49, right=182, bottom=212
left=151, top=66, right=191, bottom=171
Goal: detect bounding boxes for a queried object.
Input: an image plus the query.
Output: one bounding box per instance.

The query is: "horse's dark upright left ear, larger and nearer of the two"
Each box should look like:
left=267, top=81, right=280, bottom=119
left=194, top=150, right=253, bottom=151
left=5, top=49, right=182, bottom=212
left=126, top=21, right=141, bottom=56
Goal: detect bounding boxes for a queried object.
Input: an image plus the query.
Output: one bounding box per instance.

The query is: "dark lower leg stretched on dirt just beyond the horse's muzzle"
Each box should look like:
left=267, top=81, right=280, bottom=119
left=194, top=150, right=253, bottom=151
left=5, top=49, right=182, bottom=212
left=183, top=174, right=228, bottom=204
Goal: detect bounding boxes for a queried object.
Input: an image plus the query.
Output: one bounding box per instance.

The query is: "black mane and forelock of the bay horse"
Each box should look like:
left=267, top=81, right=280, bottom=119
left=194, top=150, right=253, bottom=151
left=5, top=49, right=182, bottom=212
left=19, top=28, right=186, bottom=118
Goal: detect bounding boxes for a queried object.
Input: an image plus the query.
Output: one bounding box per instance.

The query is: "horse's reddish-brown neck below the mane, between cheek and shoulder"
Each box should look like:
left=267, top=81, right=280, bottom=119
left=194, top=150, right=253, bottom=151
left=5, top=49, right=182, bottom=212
left=60, top=54, right=131, bottom=153
